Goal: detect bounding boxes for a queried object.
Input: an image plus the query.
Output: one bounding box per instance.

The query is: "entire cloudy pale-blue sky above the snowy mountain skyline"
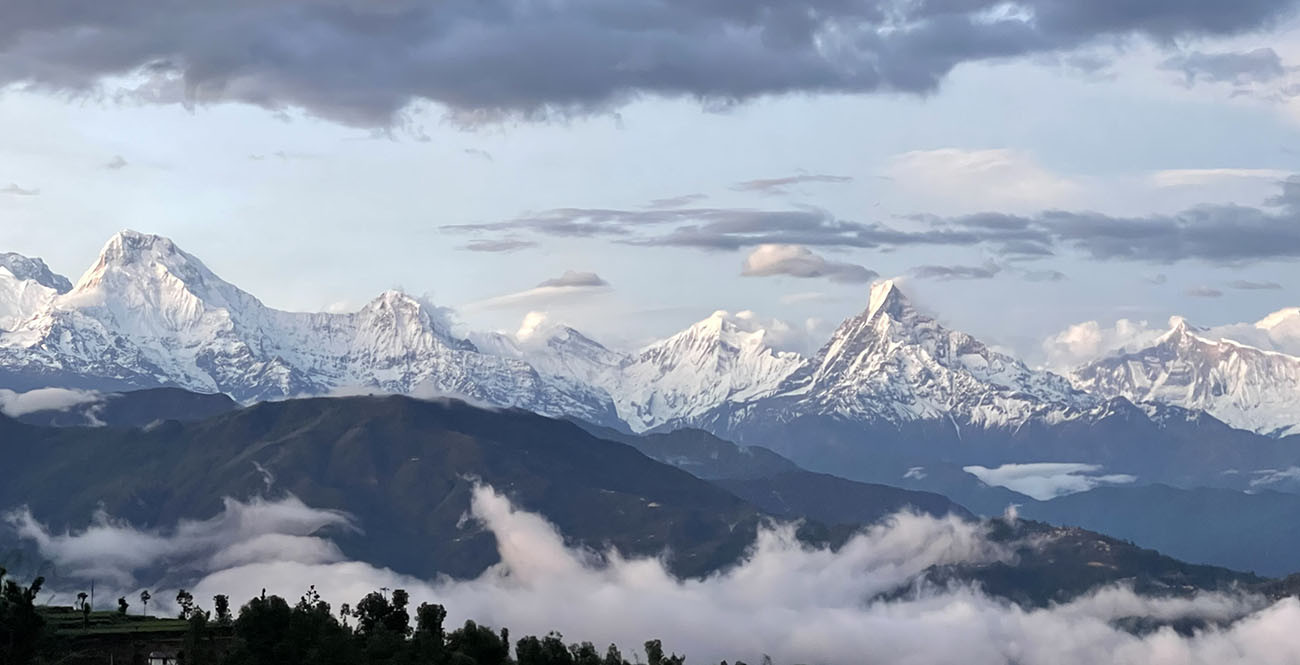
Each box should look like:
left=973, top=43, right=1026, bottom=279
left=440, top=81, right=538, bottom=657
left=0, top=0, right=1300, bottom=360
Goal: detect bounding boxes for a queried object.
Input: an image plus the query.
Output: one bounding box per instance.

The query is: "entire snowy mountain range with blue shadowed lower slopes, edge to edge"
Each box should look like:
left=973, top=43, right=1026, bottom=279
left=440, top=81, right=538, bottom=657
left=0, top=231, right=1300, bottom=488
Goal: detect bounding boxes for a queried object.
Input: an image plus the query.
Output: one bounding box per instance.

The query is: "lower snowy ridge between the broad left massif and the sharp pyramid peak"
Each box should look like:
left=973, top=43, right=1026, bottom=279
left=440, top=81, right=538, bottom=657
left=471, top=310, right=803, bottom=431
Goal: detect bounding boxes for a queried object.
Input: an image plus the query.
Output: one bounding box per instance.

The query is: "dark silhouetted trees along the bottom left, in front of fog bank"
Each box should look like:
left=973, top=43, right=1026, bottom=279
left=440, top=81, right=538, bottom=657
left=0, top=569, right=769, bottom=665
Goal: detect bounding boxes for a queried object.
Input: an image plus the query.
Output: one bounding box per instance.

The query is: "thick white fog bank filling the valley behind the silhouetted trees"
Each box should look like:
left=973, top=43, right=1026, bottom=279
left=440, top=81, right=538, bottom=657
left=10, top=487, right=1300, bottom=665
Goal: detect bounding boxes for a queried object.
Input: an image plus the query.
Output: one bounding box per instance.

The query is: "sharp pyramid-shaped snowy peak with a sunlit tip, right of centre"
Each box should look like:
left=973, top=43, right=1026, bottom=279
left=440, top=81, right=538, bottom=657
left=754, top=281, right=1100, bottom=426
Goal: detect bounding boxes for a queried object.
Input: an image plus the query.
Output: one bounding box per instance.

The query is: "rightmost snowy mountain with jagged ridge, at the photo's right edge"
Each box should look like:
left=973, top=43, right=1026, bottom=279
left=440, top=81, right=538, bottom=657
left=1071, top=316, right=1300, bottom=436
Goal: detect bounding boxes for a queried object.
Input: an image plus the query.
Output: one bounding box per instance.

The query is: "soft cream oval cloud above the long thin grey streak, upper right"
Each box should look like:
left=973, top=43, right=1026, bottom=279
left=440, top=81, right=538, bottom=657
left=887, top=148, right=1084, bottom=212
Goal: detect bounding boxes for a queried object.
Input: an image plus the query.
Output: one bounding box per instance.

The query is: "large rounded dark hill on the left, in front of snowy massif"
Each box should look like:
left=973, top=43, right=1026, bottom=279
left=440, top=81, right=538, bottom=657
left=0, top=397, right=761, bottom=577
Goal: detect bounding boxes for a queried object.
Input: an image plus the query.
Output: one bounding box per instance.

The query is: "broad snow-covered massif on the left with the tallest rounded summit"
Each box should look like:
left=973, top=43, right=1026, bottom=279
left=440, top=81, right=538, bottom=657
left=0, top=231, right=616, bottom=422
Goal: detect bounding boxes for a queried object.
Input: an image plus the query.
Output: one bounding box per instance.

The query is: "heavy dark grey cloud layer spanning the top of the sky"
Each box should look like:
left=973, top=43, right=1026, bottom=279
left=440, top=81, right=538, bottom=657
left=0, top=0, right=1295, bottom=126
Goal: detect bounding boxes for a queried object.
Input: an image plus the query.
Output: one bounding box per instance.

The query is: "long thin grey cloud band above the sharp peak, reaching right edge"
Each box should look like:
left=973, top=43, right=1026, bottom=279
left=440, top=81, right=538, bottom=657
left=442, top=178, right=1300, bottom=265
